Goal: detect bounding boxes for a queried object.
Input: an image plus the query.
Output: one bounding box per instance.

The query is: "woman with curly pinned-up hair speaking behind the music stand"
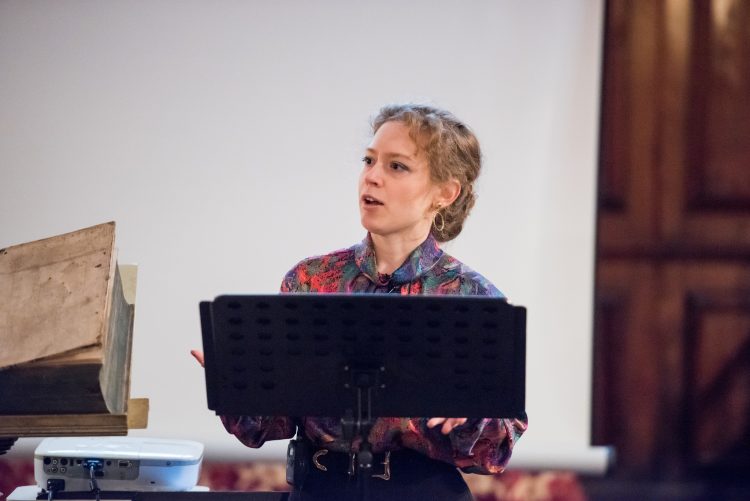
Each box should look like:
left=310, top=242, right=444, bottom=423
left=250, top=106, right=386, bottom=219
left=194, top=105, right=527, bottom=500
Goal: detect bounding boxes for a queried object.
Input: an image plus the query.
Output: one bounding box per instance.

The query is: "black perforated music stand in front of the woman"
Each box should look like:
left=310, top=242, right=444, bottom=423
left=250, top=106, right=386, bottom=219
left=200, top=294, right=526, bottom=498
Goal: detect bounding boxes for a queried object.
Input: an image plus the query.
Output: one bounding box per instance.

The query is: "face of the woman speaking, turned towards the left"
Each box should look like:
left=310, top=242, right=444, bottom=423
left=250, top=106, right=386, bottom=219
left=359, top=122, right=441, bottom=239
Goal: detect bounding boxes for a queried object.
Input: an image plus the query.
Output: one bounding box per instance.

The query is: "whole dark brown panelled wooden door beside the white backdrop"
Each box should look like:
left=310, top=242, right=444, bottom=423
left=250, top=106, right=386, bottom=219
left=592, top=0, right=750, bottom=478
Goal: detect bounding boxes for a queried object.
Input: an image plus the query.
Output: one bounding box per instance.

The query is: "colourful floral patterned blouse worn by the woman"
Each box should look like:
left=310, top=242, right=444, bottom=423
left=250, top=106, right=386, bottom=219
left=221, top=235, right=527, bottom=473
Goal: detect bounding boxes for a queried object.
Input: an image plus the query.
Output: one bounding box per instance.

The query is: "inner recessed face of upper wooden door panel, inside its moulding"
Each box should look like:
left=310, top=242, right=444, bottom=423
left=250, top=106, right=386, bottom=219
left=686, top=0, right=750, bottom=211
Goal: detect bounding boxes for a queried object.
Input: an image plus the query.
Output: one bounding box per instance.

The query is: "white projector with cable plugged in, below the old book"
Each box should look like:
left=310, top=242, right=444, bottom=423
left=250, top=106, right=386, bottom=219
left=34, top=437, right=203, bottom=491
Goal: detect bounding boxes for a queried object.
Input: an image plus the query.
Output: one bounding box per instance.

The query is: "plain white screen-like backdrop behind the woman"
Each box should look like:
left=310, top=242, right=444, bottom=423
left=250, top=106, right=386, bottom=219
left=0, top=0, right=602, bottom=468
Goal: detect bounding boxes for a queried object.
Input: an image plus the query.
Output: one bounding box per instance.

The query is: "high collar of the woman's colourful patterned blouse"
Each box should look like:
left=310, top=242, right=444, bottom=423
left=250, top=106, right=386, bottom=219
left=354, top=233, right=443, bottom=285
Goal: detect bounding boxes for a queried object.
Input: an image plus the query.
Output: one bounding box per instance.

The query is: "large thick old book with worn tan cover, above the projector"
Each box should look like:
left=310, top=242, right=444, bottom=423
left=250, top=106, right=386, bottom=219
left=0, top=223, right=133, bottom=414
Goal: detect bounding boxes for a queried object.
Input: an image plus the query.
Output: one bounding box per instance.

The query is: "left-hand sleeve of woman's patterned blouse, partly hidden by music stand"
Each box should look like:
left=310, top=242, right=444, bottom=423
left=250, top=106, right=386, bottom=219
left=220, top=265, right=304, bottom=448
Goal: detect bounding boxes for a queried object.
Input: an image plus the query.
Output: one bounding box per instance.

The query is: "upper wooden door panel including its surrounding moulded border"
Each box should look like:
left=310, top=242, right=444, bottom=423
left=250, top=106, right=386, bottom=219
left=655, top=0, right=750, bottom=250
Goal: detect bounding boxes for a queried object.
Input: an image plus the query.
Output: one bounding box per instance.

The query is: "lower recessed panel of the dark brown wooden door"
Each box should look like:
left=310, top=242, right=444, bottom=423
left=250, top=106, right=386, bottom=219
left=684, top=288, right=750, bottom=476
